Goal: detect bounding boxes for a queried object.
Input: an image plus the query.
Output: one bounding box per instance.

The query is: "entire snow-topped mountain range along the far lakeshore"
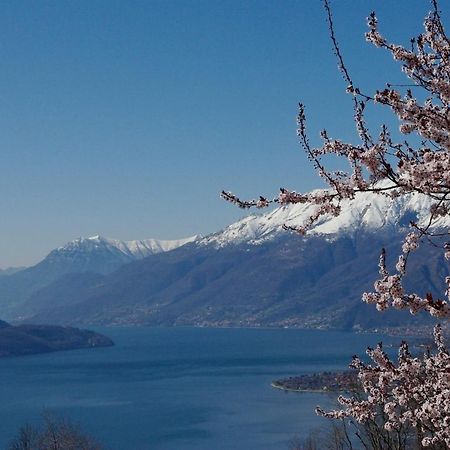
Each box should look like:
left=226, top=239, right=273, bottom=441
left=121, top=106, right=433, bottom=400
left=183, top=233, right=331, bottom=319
left=0, top=186, right=450, bottom=329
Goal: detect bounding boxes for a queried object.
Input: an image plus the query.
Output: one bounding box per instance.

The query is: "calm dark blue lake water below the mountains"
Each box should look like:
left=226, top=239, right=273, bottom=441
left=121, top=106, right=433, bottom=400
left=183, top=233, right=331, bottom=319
left=0, top=328, right=395, bottom=450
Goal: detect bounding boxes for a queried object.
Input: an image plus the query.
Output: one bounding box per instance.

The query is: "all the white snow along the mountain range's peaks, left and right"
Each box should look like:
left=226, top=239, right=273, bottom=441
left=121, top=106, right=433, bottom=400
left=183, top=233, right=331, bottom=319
left=49, top=186, right=450, bottom=260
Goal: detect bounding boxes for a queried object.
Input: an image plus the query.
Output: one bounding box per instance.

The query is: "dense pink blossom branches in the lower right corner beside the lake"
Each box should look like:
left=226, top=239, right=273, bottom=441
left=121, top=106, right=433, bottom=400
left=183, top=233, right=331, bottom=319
left=316, top=325, right=450, bottom=448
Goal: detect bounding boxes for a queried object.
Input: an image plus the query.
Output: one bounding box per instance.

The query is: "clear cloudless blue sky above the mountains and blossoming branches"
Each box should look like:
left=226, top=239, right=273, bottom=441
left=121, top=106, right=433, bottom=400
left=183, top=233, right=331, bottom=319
left=0, top=0, right=442, bottom=267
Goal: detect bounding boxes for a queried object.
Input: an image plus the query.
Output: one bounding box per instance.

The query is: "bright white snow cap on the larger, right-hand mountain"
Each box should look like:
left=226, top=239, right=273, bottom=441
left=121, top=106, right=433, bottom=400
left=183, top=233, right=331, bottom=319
left=199, top=188, right=450, bottom=247
